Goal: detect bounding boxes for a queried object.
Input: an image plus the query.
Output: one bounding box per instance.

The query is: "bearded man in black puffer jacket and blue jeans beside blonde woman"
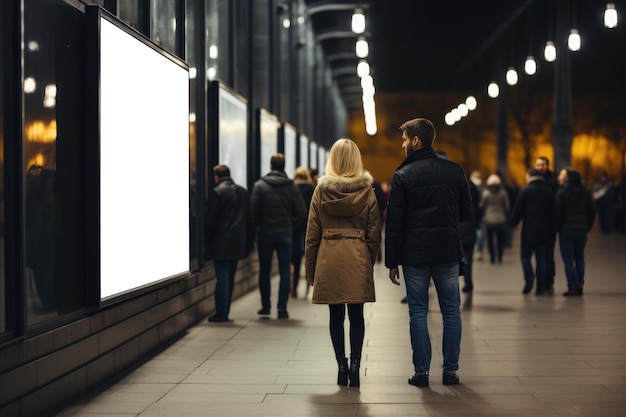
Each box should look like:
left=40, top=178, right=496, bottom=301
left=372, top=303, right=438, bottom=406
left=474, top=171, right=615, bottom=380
left=385, top=118, right=473, bottom=387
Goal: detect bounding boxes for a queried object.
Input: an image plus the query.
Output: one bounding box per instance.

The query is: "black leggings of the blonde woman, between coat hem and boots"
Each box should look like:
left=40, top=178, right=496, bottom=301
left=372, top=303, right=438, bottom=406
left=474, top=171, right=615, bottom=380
left=328, top=303, right=365, bottom=361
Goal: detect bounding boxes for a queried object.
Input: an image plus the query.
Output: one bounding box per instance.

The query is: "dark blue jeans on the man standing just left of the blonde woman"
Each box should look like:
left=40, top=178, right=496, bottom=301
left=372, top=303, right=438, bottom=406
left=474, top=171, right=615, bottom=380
left=257, top=235, right=292, bottom=310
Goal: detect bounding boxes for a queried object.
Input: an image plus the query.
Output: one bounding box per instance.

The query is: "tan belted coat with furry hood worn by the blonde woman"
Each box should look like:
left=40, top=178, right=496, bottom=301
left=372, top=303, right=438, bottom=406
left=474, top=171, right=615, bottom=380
left=304, top=174, right=381, bottom=304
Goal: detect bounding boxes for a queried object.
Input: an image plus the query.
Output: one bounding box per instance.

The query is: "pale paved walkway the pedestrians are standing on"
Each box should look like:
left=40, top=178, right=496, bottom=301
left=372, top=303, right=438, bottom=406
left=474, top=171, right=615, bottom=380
left=58, top=231, right=626, bottom=417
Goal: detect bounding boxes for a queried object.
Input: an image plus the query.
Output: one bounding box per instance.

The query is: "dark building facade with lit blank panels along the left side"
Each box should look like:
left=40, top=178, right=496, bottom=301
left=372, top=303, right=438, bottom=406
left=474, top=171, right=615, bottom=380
left=0, top=0, right=347, bottom=416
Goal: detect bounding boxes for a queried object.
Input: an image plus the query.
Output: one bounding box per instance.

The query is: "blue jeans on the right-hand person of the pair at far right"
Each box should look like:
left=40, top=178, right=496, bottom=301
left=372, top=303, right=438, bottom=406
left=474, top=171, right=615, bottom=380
left=559, top=230, right=587, bottom=291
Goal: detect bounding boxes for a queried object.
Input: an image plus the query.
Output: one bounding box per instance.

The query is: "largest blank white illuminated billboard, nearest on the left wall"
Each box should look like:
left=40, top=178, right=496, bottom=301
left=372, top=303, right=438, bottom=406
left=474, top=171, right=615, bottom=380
left=99, top=16, right=189, bottom=299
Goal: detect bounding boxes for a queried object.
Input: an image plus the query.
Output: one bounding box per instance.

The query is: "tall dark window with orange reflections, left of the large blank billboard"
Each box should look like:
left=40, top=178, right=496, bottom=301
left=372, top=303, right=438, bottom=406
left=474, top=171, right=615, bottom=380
left=24, top=0, right=86, bottom=325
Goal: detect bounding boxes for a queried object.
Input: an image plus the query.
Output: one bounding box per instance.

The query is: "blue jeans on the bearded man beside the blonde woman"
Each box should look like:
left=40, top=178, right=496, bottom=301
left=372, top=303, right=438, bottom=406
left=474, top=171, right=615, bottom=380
left=402, top=262, right=462, bottom=374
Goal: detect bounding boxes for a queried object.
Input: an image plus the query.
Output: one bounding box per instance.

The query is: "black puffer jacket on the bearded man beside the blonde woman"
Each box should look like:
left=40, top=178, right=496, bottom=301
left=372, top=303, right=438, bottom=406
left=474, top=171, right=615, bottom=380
left=385, top=148, right=473, bottom=268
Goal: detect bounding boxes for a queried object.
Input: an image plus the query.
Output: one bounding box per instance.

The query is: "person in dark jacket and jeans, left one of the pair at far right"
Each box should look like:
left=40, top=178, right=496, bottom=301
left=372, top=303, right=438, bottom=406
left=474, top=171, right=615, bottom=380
left=511, top=168, right=554, bottom=295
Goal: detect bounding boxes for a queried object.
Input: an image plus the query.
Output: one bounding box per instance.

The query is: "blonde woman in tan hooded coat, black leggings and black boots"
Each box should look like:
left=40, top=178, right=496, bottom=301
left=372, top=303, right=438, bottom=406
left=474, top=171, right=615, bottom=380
left=304, top=139, right=381, bottom=387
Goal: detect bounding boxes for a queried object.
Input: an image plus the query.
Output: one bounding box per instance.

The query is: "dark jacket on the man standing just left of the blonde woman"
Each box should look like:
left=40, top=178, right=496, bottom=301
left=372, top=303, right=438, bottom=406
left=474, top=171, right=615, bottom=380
left=250, top=171, right=306, bottom=236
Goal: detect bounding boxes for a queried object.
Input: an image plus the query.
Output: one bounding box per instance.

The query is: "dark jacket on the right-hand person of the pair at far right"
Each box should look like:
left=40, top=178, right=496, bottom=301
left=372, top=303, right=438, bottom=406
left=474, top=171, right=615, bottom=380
left=554, top=183, right=596, bottom=232
